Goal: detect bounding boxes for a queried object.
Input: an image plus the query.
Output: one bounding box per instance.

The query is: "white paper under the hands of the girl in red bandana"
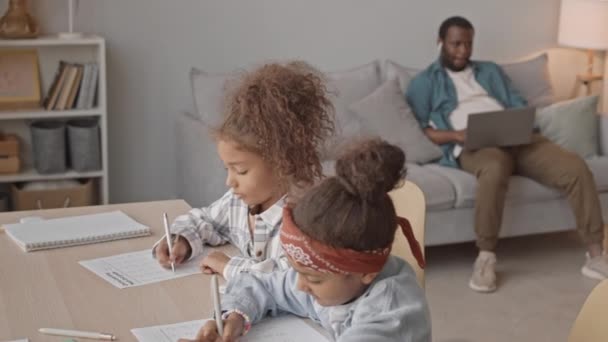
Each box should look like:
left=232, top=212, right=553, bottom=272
left=131, top=315, right=329, bottom=342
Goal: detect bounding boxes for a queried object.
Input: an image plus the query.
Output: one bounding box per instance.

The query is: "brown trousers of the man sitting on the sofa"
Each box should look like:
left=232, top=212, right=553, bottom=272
left=459, top=134, right=604, bottom=251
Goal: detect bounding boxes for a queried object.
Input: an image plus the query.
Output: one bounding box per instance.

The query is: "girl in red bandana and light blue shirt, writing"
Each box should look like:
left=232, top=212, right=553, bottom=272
left=180, top=139, right=431, bottom=342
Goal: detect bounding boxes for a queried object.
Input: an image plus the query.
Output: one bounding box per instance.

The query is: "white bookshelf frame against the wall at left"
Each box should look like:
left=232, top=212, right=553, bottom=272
left=0, top=35, right=109, bottom=204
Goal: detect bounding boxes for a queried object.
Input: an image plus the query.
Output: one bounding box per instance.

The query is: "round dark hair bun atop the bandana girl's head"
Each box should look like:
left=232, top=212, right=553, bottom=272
left=336, top=139, right=405, bottom=200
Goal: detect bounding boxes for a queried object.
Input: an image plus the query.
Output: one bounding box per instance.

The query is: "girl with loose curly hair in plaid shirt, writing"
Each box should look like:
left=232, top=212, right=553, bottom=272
left=154, top=62, right=334, bottom=279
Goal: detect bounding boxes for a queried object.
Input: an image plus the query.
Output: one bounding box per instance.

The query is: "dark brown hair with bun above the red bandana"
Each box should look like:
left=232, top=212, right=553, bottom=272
left=293, top=139, right=406, bottom=251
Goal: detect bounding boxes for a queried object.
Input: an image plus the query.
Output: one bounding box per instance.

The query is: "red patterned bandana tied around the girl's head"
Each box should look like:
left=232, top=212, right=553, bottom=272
left=280, top=208, right=424, bottom=274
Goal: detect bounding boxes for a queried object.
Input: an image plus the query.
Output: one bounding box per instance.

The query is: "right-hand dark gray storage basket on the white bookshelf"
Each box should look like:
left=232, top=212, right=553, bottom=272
left=67, top=119, right=101, bottom=172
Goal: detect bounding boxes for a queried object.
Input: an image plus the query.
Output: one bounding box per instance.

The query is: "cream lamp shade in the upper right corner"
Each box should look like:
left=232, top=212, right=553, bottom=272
left=557, top=0, right=608, bottom=50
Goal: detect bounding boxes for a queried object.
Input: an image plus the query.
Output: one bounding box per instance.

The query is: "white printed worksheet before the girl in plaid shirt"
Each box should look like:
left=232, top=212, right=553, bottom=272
left=79, top=249, right=209, bottom=289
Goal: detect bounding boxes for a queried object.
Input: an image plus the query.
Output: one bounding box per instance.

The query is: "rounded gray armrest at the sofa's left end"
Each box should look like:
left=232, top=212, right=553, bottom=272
left=175, top=112, right=227, bottom=207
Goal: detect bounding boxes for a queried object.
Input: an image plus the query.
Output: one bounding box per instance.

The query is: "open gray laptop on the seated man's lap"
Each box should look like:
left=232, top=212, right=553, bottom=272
left=464, top=107, right=536, bottom=150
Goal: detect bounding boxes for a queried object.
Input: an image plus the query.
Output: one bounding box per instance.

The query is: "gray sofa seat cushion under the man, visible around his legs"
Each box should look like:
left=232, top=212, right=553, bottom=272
left=423, top=164, right=561, bottom=208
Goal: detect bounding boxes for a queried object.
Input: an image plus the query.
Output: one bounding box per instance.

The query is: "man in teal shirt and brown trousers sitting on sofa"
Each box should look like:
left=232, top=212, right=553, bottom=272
left=406, top=17, right=608, bottom=292
